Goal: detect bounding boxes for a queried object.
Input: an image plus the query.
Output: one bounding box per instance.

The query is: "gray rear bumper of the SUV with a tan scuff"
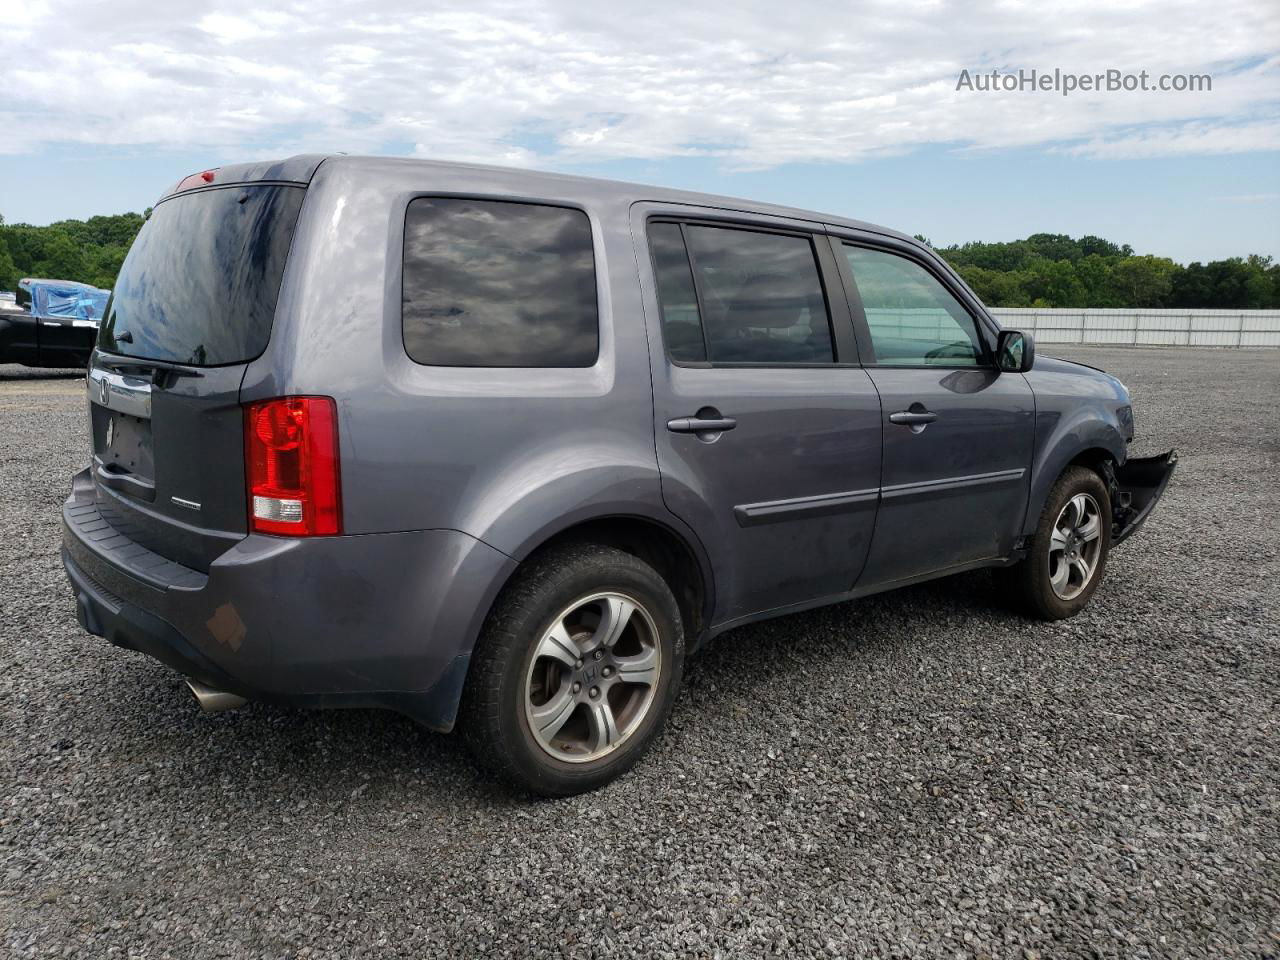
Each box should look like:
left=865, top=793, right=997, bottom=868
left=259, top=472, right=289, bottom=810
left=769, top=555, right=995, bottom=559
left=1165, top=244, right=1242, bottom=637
left=63, top=474, right=515, bottom=730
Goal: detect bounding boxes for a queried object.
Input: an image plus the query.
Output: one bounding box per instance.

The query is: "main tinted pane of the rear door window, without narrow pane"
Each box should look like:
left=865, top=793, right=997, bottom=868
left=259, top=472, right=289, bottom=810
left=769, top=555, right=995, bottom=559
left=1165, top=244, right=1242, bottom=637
left=685, top=224, right=835, bottom=364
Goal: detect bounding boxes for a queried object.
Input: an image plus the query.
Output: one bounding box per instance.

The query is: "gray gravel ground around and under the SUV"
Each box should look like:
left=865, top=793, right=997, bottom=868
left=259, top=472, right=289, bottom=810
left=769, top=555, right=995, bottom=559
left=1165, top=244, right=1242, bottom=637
left=0, top=348, right=1280, bottom=957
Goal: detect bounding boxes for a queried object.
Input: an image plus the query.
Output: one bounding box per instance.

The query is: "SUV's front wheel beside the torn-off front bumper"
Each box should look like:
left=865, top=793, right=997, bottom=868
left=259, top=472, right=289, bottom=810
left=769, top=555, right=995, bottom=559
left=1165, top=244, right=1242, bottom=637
left=1006, top=466, right=1111, bottom=620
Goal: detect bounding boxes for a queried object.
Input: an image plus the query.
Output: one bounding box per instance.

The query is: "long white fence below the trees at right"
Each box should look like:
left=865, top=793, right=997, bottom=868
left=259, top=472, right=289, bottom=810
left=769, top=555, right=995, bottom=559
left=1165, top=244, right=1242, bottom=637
left=991, top=307, right=1280, bottom=347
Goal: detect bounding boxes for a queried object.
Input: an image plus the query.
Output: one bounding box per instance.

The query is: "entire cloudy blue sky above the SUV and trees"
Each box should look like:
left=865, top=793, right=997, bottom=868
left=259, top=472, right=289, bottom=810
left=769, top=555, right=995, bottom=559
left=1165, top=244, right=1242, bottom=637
left=0, top=0, right=1280, bottom=262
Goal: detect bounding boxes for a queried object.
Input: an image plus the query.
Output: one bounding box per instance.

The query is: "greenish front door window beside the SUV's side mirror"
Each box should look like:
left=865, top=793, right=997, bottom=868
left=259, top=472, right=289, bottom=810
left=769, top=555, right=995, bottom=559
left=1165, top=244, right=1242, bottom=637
left=845, top=244, right=986, bottom=366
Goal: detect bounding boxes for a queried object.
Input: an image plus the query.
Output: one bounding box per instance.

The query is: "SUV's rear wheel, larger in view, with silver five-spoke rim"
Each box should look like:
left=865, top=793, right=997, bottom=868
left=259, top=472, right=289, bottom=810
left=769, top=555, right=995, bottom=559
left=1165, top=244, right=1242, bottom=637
left=461, top=544, right=685, bottom=796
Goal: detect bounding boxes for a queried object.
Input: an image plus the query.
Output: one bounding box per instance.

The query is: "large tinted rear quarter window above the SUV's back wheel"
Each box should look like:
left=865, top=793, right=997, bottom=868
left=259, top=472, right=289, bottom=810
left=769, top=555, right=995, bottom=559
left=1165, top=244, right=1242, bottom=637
left=402, top=197, right=600, bottom=367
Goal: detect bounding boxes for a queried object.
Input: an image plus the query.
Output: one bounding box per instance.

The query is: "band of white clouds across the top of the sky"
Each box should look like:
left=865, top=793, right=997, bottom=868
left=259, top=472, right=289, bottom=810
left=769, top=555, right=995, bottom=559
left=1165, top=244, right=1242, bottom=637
left=0, top=0, right=1280, bottom=168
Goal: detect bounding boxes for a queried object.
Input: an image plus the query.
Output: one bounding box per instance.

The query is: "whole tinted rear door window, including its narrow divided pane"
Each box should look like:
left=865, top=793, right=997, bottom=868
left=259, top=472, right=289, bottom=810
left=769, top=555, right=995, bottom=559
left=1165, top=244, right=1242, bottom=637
left=650, top=223, right=835, bottom=364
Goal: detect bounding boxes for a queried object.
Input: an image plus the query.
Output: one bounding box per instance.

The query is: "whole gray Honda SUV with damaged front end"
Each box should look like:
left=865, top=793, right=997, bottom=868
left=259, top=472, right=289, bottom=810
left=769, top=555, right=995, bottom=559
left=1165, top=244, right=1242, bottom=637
left=63, top=156, right=1175, bottom=795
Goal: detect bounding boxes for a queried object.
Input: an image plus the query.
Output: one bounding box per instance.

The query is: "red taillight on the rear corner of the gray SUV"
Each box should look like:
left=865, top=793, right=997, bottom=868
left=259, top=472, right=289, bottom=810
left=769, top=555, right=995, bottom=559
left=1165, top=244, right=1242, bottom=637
left=244, top=397, right=342, bottom=536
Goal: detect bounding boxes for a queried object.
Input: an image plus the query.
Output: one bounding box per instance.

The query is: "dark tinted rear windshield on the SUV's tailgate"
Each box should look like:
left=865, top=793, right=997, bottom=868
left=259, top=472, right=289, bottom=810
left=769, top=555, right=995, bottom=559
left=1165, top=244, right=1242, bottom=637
left=97, top=186, right=306, bottom=366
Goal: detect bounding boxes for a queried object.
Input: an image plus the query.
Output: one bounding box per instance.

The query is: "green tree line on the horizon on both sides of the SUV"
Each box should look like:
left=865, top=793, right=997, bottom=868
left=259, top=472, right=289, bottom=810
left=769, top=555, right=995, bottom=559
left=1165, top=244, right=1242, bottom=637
left=0, top=210, right=1280, bottom=310
